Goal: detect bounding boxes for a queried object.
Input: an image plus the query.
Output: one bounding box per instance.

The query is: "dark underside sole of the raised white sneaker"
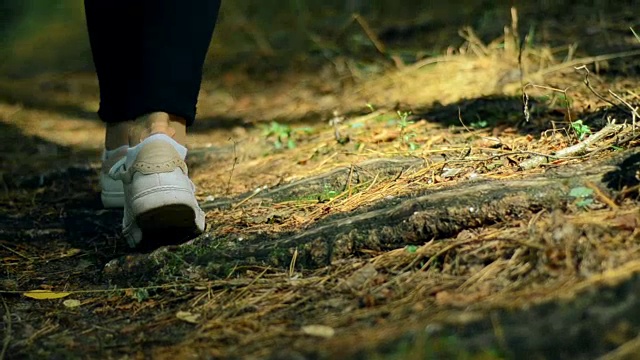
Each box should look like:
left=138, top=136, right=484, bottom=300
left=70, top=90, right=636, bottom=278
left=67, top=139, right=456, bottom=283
left=130, top=204, right=203, bottom=250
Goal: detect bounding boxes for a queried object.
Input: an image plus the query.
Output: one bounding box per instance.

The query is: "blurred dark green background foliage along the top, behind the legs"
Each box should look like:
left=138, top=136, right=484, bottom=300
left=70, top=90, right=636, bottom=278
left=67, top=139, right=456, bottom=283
left=0, top=0, right=638, bottom=77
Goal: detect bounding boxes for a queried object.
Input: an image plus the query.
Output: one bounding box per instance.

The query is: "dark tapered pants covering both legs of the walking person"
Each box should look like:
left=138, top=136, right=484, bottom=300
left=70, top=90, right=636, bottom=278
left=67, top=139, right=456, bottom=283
left=84, top=0, right=220, bottom=125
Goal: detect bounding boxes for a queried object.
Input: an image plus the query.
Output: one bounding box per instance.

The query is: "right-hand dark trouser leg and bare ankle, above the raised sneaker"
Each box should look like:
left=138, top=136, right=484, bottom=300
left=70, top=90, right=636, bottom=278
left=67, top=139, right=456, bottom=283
left=129, top=0, right=220, bottom=145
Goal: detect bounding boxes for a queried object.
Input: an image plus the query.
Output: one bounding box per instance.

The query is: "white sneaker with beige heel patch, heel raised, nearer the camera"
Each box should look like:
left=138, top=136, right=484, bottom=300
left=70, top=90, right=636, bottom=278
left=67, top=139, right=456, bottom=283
left=109, top=134, right=205, bottom=248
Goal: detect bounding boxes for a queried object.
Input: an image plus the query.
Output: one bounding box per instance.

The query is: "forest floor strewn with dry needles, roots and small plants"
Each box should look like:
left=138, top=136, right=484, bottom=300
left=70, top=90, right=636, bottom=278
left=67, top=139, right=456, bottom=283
left=5, top=8, right=640, bottom=359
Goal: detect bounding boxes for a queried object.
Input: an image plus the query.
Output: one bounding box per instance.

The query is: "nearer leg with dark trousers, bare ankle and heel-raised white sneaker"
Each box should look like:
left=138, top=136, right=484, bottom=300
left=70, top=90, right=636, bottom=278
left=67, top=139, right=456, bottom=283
left=87, top=0, right=220, bottom=246
